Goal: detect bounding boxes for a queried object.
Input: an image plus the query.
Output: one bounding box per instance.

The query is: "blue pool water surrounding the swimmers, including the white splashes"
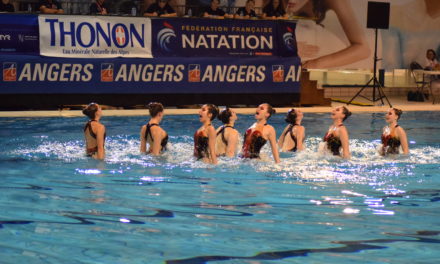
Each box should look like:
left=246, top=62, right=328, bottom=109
left=0, top=112, right=440, bottom=264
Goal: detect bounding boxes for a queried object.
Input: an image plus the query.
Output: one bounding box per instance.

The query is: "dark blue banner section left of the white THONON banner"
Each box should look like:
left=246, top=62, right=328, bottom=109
left=0, top=14, right=40, bottom=55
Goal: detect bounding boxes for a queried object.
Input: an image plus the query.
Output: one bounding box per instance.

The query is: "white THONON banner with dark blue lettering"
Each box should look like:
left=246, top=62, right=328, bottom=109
left=38, top=15, right=153, bottom=58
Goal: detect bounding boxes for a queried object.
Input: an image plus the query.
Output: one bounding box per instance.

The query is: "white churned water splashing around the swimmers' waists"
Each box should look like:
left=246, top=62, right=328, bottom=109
left=10, top=135, right=440, bottom=185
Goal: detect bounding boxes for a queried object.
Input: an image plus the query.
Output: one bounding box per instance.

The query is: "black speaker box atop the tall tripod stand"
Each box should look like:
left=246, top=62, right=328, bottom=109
left=367, top=2, right=390, bottom=29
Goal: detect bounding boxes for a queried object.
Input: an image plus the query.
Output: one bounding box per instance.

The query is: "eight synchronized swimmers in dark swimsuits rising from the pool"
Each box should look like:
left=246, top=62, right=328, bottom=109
left=83, top=102, right=409, bottom=164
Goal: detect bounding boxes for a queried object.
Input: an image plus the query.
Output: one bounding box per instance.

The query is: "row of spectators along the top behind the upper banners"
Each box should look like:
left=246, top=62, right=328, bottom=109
left=0, top=0, right=298, bottom=19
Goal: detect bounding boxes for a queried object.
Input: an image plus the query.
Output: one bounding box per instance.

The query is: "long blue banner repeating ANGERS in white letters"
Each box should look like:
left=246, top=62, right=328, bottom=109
left=0, top=56, right=301, bottom=94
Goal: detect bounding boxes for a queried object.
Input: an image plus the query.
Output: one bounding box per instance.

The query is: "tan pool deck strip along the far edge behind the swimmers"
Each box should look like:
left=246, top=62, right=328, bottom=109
left=0, top=96, right=440, bottom=117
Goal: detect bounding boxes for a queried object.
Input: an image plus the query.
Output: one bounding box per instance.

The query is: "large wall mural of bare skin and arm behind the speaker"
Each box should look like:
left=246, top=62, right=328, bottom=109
left=287, top=0, right=440, bottom=70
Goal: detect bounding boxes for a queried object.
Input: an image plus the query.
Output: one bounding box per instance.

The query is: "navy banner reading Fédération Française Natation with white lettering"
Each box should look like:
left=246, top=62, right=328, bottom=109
left=152, top=18, right=297, bottom=57
